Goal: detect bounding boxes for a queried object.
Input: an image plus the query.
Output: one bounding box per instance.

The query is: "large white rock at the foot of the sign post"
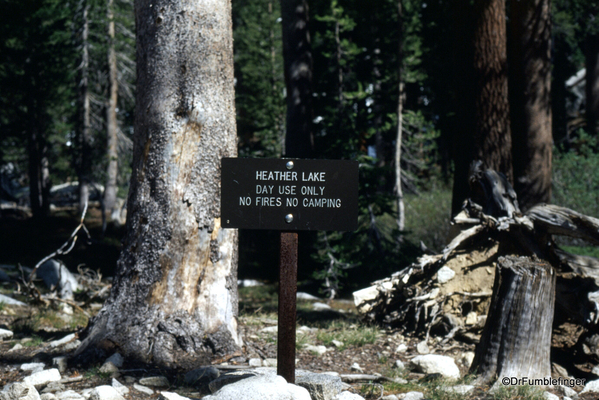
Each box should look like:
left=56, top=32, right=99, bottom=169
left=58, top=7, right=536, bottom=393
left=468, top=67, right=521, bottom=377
left=202, top=374, right=311, bottom=400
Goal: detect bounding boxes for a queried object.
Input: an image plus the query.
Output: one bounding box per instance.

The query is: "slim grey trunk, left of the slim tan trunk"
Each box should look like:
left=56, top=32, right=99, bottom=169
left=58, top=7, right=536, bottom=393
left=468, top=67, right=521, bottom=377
left=77, top=0, right=91, bottom=212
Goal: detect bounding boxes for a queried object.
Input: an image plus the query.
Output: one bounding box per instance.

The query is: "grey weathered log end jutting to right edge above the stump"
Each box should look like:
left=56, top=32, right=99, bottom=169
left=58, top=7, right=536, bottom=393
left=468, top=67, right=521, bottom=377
left=526, top=204, right=599, bottom=245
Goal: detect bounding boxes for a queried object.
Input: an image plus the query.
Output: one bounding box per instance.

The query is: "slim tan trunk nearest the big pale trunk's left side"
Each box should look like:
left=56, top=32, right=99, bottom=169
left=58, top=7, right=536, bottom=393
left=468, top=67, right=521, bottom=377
left=103, top=0, right=118, bottom=219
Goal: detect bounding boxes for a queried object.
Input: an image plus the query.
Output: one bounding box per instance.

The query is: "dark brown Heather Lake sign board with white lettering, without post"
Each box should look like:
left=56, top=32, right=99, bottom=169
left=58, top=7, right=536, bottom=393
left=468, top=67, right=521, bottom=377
left=221, top=158, right=358, bottom=231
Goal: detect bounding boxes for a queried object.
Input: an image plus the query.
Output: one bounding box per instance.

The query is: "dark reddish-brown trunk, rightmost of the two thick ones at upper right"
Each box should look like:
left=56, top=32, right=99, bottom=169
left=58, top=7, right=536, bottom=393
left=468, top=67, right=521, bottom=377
left=510, top=0, right=553, bottom=211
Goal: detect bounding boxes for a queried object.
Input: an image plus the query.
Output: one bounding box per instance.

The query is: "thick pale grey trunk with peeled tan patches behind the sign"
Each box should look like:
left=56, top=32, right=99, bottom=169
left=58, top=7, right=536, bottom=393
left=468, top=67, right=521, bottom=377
left=77, top=0, right=241, bottom=369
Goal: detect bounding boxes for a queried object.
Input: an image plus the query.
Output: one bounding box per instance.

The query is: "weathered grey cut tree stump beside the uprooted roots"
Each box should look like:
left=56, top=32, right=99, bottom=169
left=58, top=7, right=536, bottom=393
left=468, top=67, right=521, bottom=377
left=471, top=256, right=556, bottom=383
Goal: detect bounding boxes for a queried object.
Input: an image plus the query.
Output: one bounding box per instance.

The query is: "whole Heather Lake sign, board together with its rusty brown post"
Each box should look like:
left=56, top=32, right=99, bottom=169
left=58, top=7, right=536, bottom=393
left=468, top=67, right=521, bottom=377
left=221, top=158, right=358, bottom=383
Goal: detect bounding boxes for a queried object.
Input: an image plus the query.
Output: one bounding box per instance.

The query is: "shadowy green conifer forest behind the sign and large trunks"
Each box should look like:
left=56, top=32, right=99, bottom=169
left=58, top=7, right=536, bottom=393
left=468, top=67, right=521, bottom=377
left=0, top=0, right=599, bottom=296
